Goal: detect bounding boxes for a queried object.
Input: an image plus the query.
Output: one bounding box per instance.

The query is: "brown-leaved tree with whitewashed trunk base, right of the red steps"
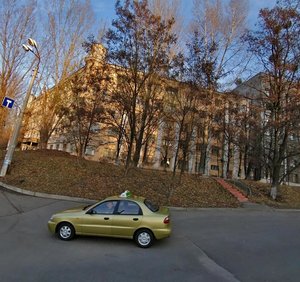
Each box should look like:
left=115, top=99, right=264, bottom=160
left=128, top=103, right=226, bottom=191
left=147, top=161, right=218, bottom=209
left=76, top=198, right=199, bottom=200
left=247, top=1, right=300, bottom=199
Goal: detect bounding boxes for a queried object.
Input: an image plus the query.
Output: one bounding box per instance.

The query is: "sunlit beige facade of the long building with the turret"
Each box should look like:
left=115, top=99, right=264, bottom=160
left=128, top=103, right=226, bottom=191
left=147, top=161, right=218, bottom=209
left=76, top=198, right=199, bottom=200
left=22, top=46, right=245, bottom=178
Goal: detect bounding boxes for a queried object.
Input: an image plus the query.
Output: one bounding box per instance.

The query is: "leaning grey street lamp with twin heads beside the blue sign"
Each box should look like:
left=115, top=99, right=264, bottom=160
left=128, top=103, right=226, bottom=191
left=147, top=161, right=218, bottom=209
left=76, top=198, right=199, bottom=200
left=0, top=38, right=40, bottom=177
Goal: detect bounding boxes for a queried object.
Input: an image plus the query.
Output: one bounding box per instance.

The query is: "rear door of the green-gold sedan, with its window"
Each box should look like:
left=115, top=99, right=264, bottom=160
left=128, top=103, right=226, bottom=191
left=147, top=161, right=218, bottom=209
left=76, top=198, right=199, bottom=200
left=111, top=199, right=143, bottom=238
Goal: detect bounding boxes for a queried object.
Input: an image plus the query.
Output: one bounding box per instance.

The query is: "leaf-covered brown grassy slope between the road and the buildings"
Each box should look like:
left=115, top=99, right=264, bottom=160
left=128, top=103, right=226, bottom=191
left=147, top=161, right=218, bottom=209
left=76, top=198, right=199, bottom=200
left=0, top=150, right=300, bottom=208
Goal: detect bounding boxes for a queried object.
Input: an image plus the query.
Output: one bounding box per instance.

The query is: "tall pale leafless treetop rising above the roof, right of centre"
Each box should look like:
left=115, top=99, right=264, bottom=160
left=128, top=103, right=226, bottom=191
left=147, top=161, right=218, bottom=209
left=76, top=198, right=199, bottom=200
left=190, top=0, right=248, bottom=88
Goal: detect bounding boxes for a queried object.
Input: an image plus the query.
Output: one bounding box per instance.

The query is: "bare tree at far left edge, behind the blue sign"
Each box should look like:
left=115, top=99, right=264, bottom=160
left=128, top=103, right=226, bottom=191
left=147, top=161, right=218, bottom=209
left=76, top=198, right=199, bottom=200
left=0, top=0, right=36, bottom=145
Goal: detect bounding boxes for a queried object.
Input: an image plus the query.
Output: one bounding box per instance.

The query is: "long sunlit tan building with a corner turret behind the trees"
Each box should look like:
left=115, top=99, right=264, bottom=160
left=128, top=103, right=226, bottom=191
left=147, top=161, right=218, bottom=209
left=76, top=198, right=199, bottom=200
left=22, top=44, right=248, bottom=178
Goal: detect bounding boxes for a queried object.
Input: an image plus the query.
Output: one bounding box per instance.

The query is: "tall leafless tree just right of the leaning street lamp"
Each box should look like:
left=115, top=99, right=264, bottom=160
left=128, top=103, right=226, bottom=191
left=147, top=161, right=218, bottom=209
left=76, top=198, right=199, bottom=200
left=32, top=0, right=93, bottom=148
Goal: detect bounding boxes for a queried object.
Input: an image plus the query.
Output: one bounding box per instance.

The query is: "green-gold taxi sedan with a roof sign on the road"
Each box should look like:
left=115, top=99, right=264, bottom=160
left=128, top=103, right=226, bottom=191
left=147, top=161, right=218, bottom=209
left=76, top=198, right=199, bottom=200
left=48, top=191, right=171, bottom=248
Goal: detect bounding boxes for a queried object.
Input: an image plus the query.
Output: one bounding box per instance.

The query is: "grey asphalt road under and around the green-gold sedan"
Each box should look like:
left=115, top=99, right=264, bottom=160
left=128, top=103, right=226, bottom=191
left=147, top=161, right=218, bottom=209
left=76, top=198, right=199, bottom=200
left=0, top=189, right=300, bottom=282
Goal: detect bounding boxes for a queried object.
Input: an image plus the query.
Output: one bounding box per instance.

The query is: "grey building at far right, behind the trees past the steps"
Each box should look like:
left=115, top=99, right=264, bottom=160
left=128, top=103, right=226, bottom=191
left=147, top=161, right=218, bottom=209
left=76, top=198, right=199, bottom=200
left=234, top=73, right=300, bottom=184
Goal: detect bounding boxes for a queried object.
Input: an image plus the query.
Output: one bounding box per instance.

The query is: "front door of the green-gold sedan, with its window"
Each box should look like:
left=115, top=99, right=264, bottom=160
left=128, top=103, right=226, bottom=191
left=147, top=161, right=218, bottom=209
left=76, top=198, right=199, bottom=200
left=80, top=200, right=117, bottom=236
